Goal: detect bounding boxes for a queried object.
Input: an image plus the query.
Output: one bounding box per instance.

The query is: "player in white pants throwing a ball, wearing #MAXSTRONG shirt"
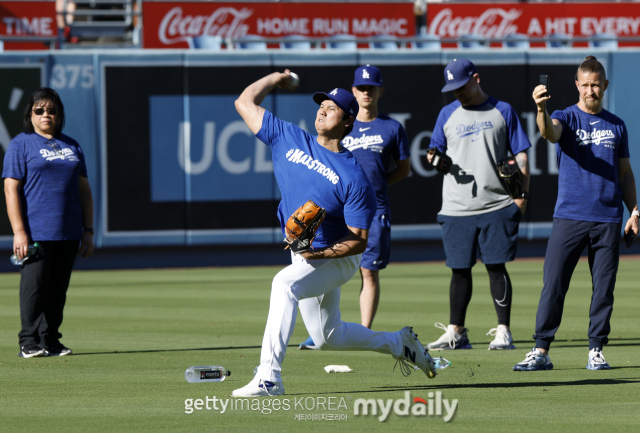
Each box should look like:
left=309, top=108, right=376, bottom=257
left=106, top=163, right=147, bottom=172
left=232, top=70, right=435, bottom=397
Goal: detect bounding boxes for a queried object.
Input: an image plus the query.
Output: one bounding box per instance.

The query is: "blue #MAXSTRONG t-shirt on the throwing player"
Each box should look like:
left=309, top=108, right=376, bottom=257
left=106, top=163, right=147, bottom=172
left=256, top=111, right=376, bottom=248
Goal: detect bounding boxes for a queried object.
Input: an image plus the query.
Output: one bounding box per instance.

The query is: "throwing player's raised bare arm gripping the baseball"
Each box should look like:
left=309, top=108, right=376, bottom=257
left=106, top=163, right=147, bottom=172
left=236, top=69, right=295, bottom=134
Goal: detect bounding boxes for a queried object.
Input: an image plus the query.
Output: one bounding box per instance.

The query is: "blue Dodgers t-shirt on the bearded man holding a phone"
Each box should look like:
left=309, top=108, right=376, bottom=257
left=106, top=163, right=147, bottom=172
left=551, top=105, right=629, bottom=223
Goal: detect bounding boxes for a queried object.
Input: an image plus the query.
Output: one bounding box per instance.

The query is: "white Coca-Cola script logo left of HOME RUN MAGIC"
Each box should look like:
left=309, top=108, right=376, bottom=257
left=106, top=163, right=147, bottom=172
left=158, top=6, right=253, bottom=44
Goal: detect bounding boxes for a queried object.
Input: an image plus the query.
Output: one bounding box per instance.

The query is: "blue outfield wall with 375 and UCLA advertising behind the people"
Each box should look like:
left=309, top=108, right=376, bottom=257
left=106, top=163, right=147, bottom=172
left=0, top=50, right=640, bottom=248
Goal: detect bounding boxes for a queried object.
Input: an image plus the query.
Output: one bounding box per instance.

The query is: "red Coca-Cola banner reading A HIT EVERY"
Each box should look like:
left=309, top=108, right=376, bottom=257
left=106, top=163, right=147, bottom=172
left=427, top=2, right=640, bottom=45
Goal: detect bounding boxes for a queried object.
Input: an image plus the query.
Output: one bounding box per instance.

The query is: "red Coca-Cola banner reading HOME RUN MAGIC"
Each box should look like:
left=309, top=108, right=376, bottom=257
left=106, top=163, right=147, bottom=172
left=143, top=2, right=415, bottom=48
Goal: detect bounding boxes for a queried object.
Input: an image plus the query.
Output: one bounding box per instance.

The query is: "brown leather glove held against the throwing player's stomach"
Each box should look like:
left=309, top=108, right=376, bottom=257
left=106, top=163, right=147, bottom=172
left=284, top=200, right=327, bottom=254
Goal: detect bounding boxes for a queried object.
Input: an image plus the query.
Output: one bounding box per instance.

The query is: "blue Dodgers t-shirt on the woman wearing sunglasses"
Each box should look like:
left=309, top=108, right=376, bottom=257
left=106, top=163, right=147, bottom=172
left=2, top=132, right=87, bottom=241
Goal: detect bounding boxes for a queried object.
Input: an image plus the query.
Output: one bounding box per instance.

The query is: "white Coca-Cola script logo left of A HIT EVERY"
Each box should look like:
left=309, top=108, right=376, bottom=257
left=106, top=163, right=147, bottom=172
left=429, top=8, right=522, bottom=39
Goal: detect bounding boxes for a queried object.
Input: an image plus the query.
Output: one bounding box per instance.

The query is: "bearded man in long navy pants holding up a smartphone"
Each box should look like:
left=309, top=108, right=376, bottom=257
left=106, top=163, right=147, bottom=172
left=513, top=56, right=639, bottom=371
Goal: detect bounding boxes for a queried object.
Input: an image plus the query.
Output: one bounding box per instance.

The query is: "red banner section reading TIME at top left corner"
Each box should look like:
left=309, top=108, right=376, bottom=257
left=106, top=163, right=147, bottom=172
left=0, top=1, right=58, bottom=50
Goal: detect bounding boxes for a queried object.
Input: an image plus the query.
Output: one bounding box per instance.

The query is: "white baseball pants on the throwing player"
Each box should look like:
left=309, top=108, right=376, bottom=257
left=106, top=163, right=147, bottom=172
left=257, top=254, right=402, bottom=382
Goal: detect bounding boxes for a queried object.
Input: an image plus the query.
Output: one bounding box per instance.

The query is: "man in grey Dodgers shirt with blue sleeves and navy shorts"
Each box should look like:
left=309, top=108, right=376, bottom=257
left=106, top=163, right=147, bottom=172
left=427, top=59, right=531, bottom=350
